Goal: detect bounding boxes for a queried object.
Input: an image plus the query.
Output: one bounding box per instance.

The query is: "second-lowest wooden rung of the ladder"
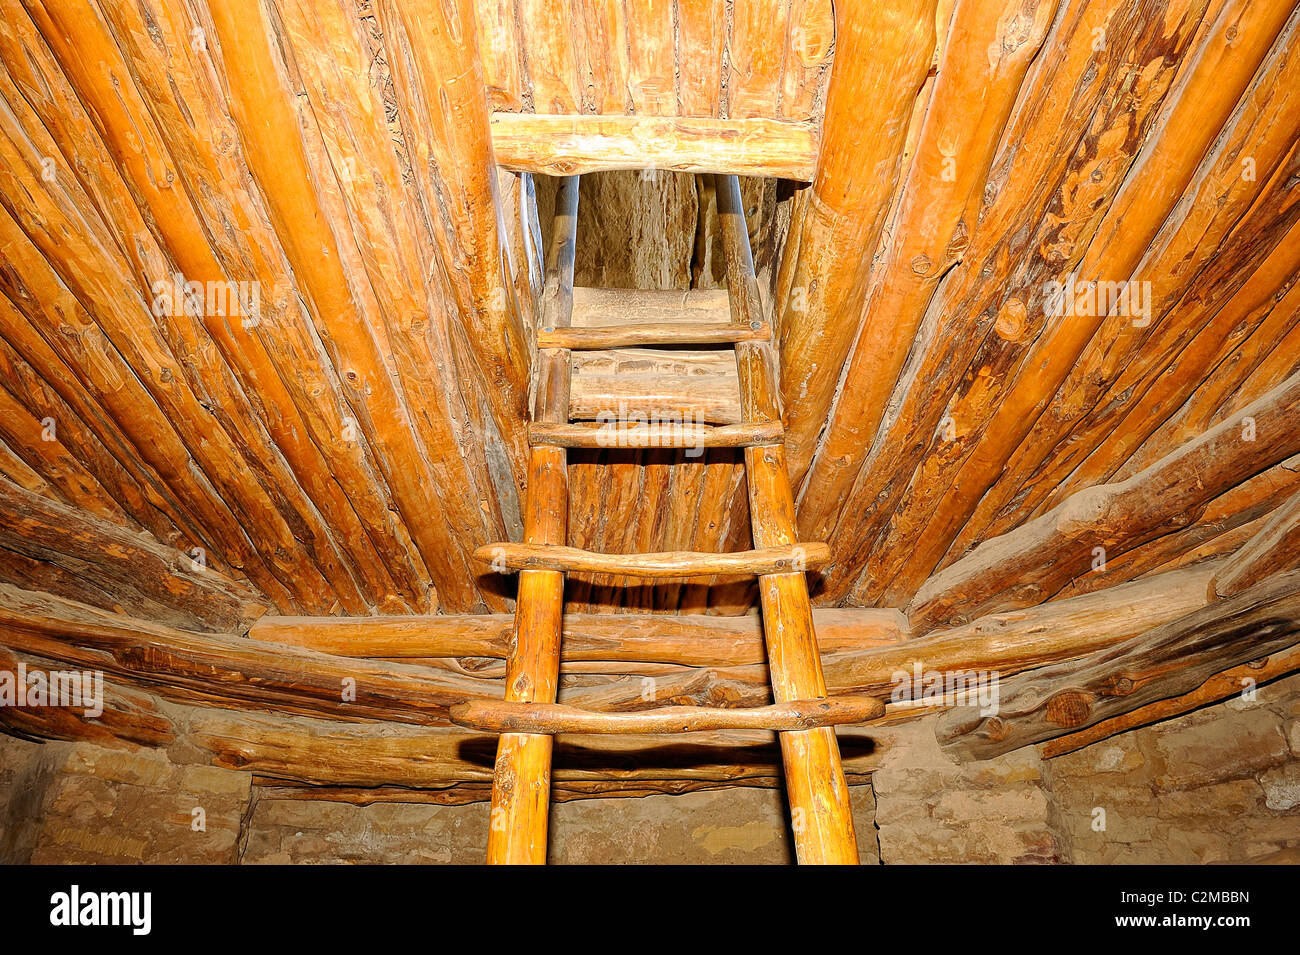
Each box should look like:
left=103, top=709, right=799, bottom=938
left=475, top=542, right=831, bottom=579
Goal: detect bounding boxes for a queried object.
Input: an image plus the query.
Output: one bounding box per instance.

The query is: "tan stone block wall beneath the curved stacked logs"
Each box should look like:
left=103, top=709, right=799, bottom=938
left=0, top=674, right=1300, bottom=864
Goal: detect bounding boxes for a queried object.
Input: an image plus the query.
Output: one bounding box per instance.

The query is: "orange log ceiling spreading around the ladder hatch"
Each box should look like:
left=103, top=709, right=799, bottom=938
left=0, top=0, right=1300, bottom=629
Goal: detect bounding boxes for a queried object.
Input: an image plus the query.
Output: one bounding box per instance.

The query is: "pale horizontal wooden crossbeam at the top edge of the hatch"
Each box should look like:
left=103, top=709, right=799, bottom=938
left=491, top=113, right=818, bottom=182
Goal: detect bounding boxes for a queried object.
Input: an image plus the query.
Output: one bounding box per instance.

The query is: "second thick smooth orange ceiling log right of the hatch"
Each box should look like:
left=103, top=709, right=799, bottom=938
left=800, top=0, right=1058, bottom=541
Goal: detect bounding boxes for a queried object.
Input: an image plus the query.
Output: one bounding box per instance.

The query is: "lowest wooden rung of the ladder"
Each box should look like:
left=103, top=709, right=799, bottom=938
left=451, top=694, right=885, bottom=735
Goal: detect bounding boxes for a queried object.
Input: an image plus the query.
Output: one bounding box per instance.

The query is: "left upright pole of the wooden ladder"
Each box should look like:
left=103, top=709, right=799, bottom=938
left=488, top=175, right=579, bottom=865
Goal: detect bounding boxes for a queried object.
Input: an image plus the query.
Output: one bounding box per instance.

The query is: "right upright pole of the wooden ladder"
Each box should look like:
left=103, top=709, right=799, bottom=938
left=714, top=175, right=858, bottom=865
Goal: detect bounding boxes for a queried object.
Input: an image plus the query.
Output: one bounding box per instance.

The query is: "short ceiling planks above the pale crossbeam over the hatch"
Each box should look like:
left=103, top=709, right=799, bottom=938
left=475, top=0, right=835, bottom=121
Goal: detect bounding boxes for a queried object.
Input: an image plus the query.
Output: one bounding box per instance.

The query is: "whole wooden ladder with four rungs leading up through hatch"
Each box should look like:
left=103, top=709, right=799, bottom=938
left=451, top=175, right=884, bottom=864
